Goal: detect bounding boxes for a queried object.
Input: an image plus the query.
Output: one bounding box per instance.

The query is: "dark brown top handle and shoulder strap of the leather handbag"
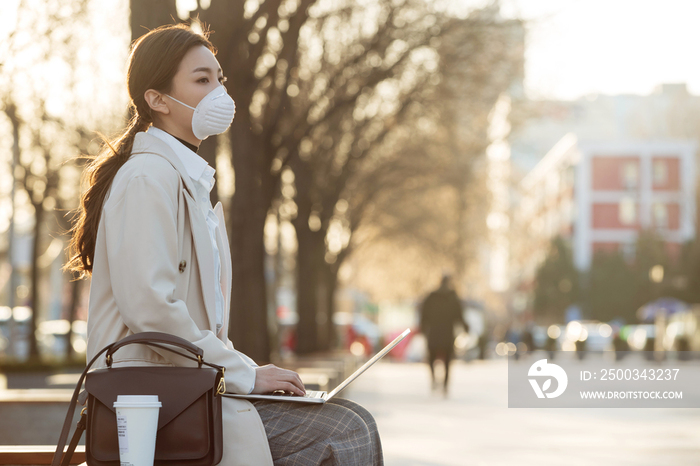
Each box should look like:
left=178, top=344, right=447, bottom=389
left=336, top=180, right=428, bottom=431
left=51, top=332, right=223, bottom=466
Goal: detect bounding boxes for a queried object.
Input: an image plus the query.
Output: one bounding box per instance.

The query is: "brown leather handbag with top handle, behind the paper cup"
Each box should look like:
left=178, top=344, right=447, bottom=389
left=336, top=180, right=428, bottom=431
left=51, top=332, right=226, bottom=466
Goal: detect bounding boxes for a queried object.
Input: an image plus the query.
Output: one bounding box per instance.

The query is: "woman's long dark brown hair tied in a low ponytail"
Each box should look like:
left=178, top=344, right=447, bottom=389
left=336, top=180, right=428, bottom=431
left=64, top=24, right=216, bottom=277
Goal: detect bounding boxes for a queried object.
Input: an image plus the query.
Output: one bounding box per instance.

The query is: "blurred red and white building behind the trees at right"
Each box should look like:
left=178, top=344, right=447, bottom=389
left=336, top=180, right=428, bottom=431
left=517, top=134, right=697, bottom=277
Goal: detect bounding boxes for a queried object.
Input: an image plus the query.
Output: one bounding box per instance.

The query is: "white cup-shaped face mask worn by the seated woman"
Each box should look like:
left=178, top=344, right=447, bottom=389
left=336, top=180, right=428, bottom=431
left=165, top=86, right=236, bottom=140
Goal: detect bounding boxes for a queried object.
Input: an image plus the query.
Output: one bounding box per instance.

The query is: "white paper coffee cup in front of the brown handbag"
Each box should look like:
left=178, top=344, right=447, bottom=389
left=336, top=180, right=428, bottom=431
left=114, top=395, right=161, bottom=466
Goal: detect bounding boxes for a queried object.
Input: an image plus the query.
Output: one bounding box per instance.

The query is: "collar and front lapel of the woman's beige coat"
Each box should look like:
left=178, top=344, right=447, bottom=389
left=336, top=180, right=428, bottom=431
left=132, top=133, right=219, bottom=333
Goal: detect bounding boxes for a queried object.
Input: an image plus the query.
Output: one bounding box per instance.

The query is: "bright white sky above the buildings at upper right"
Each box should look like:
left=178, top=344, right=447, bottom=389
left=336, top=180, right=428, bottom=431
left=502, top=0, right=700, bottom=99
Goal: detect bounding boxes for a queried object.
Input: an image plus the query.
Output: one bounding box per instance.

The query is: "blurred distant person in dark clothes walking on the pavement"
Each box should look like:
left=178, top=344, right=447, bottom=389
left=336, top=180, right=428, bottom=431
left=420, top=275, right=469, bottom=394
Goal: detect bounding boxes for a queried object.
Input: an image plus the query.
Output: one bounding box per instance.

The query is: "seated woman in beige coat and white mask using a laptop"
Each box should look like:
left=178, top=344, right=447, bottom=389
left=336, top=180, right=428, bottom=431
left=66, top=25, right=382, bottom=466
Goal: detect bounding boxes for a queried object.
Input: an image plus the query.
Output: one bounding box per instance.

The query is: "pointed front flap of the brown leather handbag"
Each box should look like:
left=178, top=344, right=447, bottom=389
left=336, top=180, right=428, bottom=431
left=85, top=366, right=218, bottom=430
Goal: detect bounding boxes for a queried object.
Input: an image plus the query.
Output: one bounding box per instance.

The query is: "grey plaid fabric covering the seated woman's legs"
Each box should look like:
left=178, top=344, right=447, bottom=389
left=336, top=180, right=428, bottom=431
left=253, top=398, right=384, bottom=466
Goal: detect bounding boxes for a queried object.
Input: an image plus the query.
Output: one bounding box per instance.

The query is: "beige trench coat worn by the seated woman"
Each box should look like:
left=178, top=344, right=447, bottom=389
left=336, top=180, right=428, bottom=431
left=87, top=133, right=272, bottom=466
